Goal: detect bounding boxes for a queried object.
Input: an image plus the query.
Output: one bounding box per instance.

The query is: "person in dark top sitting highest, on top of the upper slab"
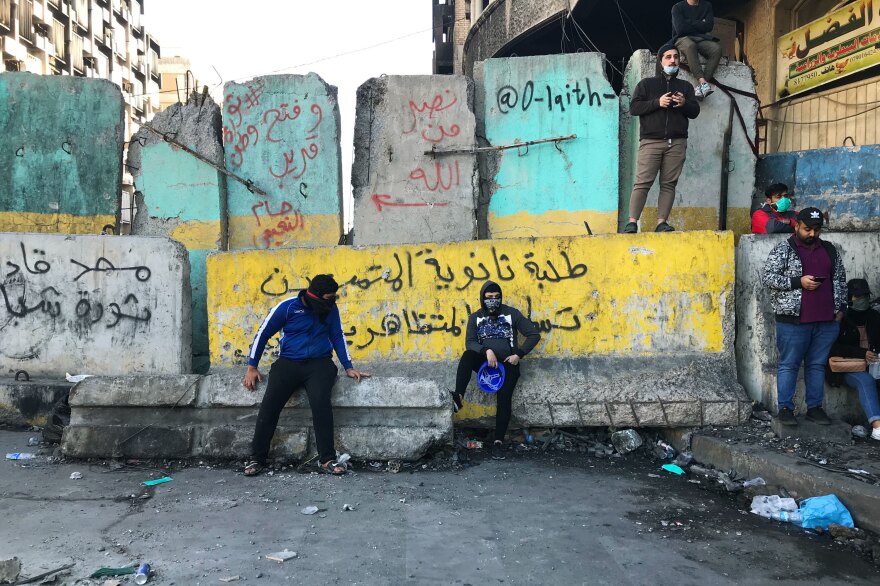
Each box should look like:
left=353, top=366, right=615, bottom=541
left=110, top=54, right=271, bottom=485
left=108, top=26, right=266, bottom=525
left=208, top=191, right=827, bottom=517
left=672, top=0, right=721, bottom=100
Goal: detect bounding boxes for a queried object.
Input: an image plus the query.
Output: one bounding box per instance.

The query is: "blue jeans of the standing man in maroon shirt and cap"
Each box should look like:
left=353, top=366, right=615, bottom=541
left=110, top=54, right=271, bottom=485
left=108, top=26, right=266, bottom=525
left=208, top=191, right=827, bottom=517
left=776, top=321, right=840, bottom=411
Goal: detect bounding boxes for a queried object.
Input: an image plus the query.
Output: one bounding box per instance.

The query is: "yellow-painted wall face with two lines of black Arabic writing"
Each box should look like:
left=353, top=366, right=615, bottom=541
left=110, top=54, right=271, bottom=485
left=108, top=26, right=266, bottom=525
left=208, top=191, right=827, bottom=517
left=208, top=232, right=734, bottom=366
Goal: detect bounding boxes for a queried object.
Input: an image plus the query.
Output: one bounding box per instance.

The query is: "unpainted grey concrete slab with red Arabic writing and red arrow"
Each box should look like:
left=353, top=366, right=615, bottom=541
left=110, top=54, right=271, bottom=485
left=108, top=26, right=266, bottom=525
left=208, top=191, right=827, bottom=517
left=351, top=75, right=478, bottom=245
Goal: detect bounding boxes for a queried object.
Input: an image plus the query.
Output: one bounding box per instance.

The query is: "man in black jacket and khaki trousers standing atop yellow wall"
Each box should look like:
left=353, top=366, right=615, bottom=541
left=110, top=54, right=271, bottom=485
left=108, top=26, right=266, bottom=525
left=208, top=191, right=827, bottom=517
left=623, top=44, right=700, bottom=234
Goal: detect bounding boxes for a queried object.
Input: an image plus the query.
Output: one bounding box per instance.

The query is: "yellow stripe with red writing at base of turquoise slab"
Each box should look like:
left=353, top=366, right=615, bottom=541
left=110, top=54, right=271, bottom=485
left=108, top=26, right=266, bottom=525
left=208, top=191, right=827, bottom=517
left=229, top=214, right=342, bottom=250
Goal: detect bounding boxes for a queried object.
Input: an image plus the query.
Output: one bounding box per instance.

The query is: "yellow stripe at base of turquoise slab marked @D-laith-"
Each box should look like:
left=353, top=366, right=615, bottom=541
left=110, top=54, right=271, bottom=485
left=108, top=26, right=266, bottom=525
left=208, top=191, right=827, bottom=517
left=489, top=210, right=617, bottom=238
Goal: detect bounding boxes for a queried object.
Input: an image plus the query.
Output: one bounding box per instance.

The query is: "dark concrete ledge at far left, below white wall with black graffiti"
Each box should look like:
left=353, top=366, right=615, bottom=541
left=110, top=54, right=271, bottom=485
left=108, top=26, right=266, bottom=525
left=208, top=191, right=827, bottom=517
left=0, top=378, right=73, bottom=427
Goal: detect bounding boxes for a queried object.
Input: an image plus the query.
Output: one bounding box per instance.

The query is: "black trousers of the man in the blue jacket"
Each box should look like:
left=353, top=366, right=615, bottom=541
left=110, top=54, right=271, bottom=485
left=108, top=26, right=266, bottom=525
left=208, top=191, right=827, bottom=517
left=251, top=358, right=336, bottom=464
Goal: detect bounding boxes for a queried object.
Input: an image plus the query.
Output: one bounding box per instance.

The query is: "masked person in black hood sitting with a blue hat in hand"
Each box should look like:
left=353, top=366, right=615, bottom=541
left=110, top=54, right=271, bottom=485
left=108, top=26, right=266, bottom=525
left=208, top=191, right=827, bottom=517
left=451, top=281, right=541, bottom=460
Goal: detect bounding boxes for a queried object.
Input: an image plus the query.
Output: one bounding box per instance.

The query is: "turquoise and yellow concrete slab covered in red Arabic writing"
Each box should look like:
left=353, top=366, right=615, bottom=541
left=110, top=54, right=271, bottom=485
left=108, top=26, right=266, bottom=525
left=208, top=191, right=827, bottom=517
left=223, top=73, right=342, bottom=250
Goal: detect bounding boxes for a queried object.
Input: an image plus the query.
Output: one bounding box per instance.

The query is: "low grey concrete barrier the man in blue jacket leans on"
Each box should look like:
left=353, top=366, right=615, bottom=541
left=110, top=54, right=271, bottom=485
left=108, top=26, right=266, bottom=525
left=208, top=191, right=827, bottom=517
left=62, top=366, right=452, bottom=460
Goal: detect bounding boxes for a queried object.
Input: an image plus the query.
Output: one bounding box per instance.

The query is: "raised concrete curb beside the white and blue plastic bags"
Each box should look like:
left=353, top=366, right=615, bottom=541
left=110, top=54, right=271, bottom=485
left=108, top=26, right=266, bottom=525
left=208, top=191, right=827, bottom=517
left=691, top=435, right=880, bottom=532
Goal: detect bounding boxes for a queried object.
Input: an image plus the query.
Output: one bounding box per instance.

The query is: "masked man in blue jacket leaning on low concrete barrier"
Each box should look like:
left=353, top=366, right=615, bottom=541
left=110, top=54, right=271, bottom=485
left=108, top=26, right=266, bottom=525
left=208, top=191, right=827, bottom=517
left=243, top=275, right=370, bottom=476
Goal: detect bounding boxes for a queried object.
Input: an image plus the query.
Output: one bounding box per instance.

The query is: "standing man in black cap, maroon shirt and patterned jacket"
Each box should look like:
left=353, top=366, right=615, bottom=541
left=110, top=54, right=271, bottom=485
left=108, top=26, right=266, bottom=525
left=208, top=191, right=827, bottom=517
left=763, top=208, right=846, bottom=426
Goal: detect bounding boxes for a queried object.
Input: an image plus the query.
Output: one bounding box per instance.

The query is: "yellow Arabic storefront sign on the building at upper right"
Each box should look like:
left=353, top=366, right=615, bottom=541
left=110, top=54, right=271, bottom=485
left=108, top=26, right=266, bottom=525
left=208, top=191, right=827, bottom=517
left=776, top=0, right=880, bottom=99
